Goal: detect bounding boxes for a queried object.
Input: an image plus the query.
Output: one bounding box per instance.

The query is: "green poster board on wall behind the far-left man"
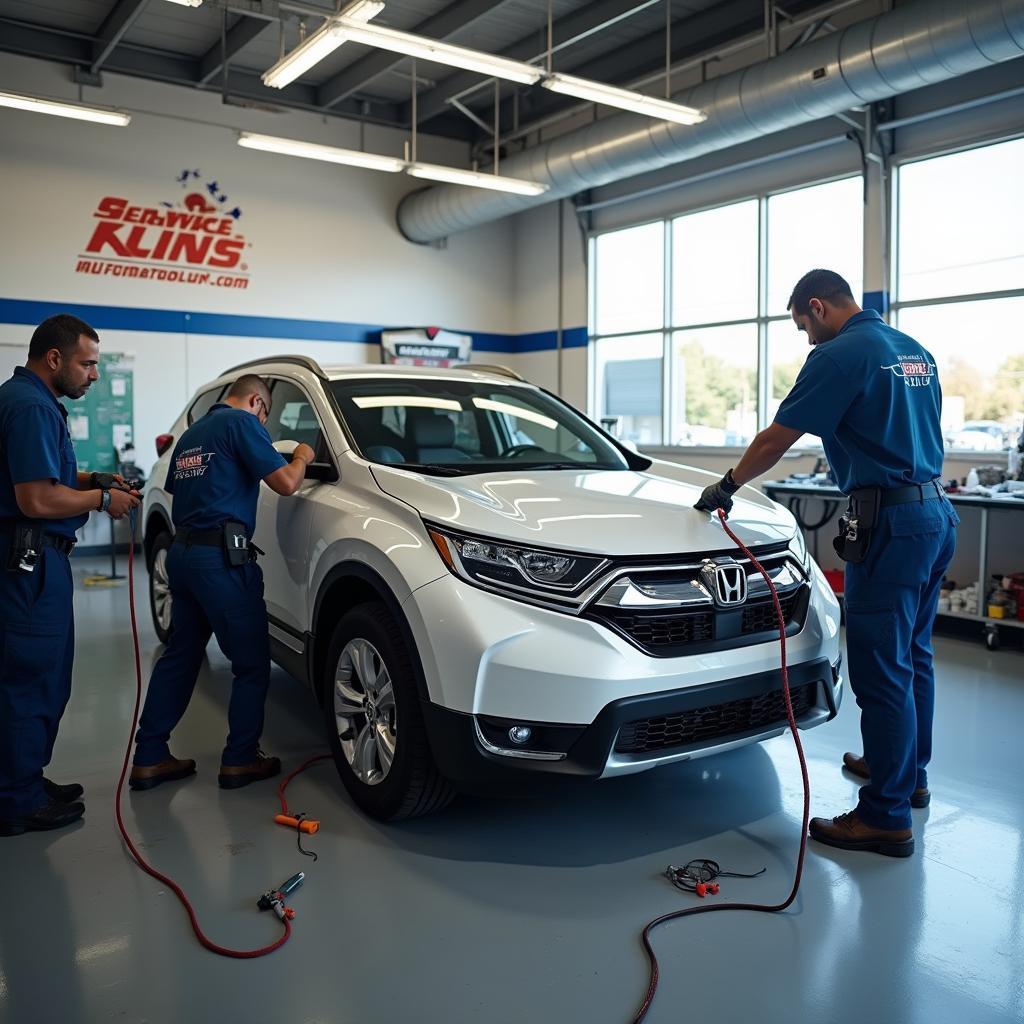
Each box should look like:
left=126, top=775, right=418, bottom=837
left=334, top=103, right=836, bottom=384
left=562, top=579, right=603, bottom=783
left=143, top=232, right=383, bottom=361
left=74, top=352, right=135, bottom=473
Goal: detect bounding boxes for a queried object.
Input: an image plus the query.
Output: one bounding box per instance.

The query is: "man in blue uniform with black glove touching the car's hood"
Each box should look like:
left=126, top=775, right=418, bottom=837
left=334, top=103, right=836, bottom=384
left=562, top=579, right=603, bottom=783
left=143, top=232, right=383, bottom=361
left=696, top=270, right=959, bottom=857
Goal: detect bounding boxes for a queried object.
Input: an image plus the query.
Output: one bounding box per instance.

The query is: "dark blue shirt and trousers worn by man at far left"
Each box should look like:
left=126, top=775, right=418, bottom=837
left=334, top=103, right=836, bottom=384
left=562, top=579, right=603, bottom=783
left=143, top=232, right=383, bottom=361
left=0, top=367, right=88, bottom=818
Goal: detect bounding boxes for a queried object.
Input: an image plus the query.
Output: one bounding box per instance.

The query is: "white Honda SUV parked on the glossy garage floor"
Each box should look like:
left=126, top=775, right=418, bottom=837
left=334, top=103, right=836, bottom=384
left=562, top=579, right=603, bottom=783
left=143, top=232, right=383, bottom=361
left=143, top=356, right=842, bottom=819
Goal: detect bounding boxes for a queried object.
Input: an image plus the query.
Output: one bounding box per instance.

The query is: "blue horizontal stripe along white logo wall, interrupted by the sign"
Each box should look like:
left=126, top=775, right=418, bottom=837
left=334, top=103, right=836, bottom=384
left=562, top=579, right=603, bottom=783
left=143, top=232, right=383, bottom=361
left=0, top=299, right=587, bottom=355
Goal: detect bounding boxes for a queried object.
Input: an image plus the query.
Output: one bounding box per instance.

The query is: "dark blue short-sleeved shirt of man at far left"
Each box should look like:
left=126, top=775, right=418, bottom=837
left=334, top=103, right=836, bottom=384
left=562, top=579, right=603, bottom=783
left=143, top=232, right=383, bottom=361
left=0, top=367, right=89, bottom=538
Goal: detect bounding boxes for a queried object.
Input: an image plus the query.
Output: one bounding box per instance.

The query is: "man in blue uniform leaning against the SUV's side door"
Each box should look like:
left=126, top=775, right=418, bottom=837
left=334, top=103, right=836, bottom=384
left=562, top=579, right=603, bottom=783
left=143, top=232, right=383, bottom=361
left=128, top=374, right=313, bottom=790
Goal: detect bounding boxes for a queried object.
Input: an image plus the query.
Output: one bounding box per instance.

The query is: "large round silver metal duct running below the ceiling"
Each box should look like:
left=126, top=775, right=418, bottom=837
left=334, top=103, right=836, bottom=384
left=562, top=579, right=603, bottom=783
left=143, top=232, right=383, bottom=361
left=398, top=0, right=1024, bottom=243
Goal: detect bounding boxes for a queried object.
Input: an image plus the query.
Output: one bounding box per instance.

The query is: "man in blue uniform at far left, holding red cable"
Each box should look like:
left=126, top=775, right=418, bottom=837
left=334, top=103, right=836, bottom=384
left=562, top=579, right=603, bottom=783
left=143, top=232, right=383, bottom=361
left=0, top=313, right=139, bottom=836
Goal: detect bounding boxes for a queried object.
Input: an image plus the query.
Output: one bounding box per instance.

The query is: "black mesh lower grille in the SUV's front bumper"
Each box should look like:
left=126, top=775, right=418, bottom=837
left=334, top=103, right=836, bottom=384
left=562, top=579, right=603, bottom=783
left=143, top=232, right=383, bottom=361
left=615, top=683, right=817, bottom=754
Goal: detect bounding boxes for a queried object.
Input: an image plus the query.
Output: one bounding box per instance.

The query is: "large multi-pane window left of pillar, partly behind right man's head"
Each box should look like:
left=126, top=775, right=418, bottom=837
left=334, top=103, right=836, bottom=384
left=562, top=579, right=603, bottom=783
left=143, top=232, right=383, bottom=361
left=591, top=177, right=863, bottom=446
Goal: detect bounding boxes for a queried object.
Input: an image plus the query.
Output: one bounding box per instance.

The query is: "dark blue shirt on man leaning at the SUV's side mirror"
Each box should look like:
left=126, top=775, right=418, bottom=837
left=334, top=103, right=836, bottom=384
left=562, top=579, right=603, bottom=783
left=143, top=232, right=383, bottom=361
left=165, top=402, right=288, bottom=538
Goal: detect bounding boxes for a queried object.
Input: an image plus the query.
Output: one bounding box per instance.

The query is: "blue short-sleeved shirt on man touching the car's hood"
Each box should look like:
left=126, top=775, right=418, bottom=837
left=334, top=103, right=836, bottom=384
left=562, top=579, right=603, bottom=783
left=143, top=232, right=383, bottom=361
left=775, top=309, right=944, bottom=494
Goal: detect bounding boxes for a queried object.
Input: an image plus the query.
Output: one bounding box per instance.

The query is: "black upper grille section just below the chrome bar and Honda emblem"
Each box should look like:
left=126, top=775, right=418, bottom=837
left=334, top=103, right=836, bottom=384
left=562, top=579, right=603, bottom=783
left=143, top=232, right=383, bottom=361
left=594, top=587, right=807, bottom=657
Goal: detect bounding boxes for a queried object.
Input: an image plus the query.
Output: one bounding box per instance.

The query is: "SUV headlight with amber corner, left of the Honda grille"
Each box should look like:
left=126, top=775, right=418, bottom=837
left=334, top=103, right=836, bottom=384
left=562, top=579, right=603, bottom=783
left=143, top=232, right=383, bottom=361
left=427, top=525, right=606, bottom=597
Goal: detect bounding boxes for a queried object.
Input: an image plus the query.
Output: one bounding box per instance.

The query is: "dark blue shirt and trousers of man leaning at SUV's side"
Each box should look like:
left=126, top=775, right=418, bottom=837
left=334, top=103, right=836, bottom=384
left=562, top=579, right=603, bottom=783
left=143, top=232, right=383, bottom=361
left=134, top=403, right=287, bottom=766
